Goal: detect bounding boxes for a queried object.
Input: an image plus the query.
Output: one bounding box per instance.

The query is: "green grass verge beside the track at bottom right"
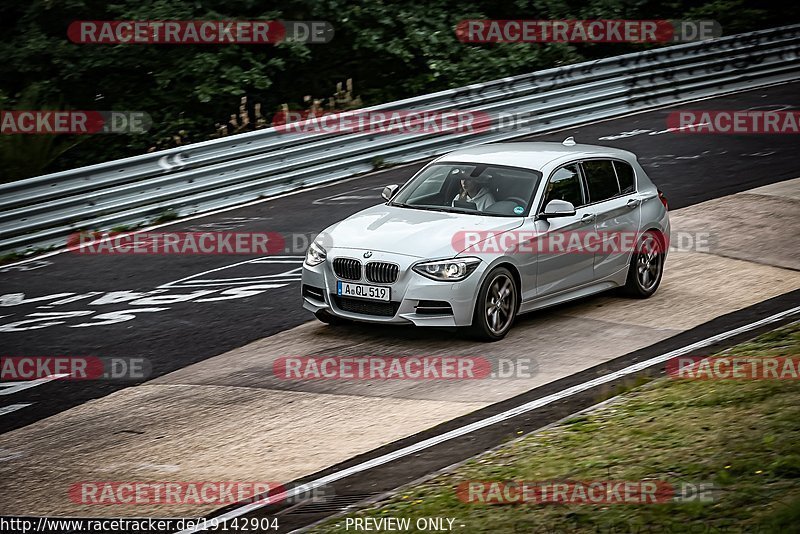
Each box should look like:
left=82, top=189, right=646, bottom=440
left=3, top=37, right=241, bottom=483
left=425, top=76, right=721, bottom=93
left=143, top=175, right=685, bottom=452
left=313, top=324, right=800, bottom=533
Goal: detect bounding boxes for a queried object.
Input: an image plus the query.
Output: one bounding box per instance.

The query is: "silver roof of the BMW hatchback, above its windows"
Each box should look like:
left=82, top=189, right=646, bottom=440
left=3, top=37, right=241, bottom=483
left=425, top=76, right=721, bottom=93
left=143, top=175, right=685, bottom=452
left=436, top=142, right=636, bottom=170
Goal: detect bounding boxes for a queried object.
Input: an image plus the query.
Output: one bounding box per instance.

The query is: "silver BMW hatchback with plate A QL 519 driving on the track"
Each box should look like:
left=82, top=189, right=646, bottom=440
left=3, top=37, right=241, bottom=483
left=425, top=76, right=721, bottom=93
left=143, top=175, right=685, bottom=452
left=302, top=138, right=670, bottom=341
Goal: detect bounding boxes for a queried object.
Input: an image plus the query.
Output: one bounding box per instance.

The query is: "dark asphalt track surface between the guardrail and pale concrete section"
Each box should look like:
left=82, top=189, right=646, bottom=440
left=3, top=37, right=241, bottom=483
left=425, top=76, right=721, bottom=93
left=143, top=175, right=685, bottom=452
left=0, top=84, right=800, bottom=432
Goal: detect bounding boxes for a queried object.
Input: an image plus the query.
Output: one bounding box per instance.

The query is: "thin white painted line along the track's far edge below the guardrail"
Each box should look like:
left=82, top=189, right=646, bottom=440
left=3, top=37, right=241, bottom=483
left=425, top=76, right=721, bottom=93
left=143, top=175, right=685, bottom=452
left=3, top=80, right=796, bottom=268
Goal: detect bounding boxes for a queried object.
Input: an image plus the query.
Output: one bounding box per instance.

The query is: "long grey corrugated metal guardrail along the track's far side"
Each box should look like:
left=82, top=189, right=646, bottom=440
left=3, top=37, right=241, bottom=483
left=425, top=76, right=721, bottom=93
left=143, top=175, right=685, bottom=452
left=0, top=25, right=800, bottom=258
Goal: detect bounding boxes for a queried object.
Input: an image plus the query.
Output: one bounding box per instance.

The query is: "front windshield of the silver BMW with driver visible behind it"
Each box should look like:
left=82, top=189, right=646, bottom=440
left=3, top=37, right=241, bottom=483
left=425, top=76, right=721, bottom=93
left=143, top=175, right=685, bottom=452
left=391, top=163, right=542, bottom=217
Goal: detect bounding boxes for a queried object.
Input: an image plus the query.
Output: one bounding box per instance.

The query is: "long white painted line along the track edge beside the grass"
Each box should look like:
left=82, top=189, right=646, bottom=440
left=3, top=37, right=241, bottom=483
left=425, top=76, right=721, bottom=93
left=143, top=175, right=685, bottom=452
left=177, top=306, right=800, bottom=534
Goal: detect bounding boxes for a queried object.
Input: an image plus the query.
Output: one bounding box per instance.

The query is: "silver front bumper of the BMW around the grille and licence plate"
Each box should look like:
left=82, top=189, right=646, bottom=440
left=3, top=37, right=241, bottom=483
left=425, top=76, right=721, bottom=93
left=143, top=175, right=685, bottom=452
left=301, top=249, right=487, bottom=326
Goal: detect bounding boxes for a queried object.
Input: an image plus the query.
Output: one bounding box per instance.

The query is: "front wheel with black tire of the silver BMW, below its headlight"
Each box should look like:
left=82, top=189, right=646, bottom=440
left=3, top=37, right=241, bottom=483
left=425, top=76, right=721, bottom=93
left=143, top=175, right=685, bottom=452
left=470, top=267, right=519, bottom=341
